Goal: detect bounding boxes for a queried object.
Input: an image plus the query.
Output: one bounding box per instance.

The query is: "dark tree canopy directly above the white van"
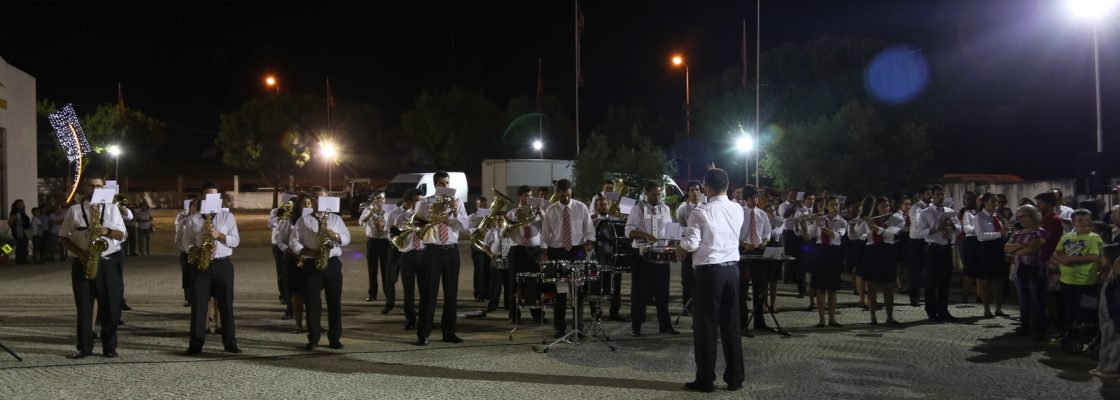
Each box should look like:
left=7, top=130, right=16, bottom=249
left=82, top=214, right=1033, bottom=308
left=401, top=86, right=502, bottom=170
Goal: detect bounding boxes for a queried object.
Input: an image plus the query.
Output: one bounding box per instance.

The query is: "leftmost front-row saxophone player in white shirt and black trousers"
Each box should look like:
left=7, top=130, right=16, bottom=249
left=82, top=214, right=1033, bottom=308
left=58, top=178, right=127, bottom=359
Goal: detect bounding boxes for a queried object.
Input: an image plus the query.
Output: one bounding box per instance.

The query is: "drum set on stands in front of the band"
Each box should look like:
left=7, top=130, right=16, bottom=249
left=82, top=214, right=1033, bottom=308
left=510, top=256, right=615, bottom=353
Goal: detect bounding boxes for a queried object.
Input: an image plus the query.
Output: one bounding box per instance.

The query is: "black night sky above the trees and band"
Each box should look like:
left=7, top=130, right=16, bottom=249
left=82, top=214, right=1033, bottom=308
left=0, top=0, right=1120, bottom=178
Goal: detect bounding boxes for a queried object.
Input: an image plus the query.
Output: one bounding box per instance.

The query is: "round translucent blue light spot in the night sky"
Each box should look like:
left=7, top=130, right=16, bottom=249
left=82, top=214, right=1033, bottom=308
left=864, top=45, right=930, bottom=104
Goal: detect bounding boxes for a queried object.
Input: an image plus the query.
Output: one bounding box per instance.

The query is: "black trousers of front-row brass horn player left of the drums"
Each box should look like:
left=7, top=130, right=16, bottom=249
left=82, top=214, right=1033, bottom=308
left=417, top=244, right=459, bottom=339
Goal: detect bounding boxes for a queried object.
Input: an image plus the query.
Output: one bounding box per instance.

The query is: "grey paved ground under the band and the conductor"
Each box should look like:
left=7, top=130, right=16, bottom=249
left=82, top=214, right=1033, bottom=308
left=0, top=238, right=1120, bottom=399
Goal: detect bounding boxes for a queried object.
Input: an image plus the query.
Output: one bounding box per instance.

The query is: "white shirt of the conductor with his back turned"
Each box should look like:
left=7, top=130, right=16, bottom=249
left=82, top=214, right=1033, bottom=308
left=681, top=195, right=743, bottom=264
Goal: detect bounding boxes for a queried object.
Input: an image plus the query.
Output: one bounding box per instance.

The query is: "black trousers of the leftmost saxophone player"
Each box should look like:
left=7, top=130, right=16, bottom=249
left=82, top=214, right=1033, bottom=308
left=71, top=251, right=121, bottom=353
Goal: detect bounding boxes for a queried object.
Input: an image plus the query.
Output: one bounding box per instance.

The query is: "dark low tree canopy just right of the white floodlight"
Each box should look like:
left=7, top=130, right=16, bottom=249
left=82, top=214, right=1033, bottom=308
left=762, top=102, right=932, bottom=195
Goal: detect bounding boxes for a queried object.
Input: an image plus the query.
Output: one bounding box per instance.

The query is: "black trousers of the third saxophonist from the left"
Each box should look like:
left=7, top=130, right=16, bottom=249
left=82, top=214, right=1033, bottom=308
left=302, top=257, right=343, bottom=345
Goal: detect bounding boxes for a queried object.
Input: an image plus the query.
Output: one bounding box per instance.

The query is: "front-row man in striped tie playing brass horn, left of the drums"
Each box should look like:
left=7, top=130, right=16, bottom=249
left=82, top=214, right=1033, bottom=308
left=416, top=171, right=467, bottom=345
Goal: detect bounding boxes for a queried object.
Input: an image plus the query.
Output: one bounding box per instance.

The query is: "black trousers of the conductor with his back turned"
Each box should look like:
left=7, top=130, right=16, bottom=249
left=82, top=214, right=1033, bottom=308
left=689, top=261, right=744, bottom=384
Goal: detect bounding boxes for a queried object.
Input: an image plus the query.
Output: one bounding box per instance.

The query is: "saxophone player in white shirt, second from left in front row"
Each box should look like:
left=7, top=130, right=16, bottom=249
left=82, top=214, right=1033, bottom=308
left=179, top=182, right=241, bottom=354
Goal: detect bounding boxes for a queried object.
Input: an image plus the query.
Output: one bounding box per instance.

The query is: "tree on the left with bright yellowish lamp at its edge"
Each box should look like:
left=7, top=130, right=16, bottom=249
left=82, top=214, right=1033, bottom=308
left=215, top=94, right=326, bottom=207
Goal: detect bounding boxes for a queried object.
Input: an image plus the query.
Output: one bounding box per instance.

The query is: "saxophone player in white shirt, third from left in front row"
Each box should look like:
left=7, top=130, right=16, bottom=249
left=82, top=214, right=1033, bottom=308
left=288, top=186, right=351, bottom=351
